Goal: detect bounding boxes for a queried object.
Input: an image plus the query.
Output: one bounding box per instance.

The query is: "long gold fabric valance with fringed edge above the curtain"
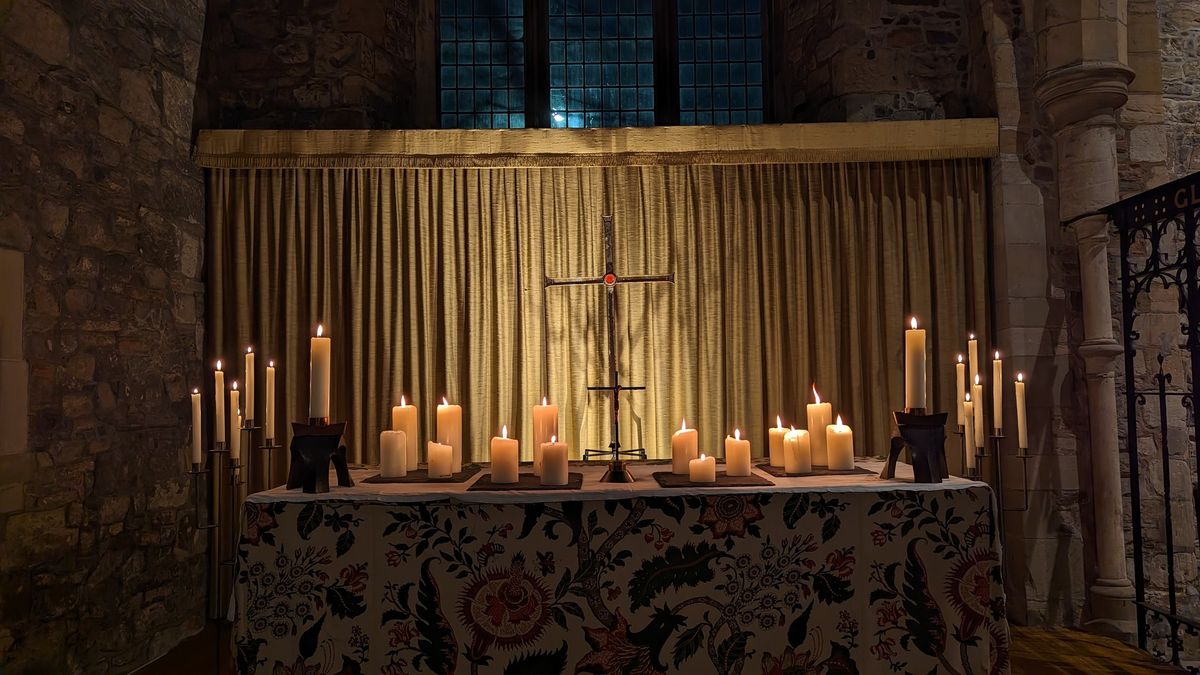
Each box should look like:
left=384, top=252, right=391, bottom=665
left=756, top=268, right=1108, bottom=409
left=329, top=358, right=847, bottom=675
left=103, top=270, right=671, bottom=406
left=194, top=118, right=997, bottom=168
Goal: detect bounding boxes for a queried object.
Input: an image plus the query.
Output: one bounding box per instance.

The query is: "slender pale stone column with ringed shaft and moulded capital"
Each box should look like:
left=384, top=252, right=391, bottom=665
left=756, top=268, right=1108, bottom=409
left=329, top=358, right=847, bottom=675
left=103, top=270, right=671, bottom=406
left=1036, top=62, right=1134, bottom=638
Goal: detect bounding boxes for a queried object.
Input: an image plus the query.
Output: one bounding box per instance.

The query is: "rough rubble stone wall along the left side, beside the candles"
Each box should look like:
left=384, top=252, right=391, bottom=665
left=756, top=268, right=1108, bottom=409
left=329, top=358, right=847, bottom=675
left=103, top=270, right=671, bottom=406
left=0, top=0, right=205, bottom=674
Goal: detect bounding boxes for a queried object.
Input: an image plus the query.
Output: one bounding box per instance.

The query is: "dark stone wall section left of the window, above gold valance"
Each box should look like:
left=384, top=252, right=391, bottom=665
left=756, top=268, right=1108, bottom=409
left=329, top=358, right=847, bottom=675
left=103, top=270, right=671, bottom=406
left=202, top=0, right=437, bottom=129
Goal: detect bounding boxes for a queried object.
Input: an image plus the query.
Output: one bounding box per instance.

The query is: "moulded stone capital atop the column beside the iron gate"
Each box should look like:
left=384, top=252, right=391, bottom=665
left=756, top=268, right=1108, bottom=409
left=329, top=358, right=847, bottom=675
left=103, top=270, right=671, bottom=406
left=1033, top=61, right=1134, bottom=130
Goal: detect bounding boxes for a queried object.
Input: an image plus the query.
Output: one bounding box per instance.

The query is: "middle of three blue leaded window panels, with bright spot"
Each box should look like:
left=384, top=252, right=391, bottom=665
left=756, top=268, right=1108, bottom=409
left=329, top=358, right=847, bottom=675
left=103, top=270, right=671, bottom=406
left=548, top=0, right=654, bottom=127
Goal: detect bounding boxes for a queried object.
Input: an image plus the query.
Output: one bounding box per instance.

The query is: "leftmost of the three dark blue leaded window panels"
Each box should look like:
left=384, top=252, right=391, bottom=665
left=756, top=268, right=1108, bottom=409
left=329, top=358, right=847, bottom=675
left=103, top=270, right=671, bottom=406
left=438, top=0, right=526, bottom=129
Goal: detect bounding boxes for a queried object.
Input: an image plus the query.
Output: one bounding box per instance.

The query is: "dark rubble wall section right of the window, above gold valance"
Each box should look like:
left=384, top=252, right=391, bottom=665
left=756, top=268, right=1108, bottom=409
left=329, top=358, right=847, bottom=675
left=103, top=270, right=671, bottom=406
left=772, top=0, right=991, bottom=121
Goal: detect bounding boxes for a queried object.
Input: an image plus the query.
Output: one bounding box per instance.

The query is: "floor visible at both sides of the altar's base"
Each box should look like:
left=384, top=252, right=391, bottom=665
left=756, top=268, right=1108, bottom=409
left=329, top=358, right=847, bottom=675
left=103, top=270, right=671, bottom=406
left=137, top=623, right=1182, bottom=675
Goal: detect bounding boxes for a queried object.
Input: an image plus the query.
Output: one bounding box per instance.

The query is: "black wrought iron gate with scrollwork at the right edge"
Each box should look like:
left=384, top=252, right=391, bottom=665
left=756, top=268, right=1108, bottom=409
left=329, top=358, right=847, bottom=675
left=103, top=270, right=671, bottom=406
left=1105, top=173, right=1200, bottom=673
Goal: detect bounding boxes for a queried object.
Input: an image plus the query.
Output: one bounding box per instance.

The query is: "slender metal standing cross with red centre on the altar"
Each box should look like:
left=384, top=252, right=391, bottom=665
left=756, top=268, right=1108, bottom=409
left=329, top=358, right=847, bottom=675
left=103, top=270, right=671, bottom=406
left=546, top=216, right=674, bottom=483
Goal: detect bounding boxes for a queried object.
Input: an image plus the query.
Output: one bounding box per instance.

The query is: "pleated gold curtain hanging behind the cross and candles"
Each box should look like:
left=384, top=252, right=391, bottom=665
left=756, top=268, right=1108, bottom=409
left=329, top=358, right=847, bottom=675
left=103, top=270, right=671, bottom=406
left=208, top=159, right=988, bottom=470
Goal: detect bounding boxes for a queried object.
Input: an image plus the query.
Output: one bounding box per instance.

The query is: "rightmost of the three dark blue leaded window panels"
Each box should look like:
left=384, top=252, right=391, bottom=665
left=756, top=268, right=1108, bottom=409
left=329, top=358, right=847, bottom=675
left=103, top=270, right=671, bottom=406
left=678, top=0, right=763, bottom=124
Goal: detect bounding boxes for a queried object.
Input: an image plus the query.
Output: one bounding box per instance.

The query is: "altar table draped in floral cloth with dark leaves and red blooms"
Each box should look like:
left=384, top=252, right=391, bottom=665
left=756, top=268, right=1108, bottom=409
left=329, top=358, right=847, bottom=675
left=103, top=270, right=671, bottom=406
left=234, top=461, right=1009, bottom=675
